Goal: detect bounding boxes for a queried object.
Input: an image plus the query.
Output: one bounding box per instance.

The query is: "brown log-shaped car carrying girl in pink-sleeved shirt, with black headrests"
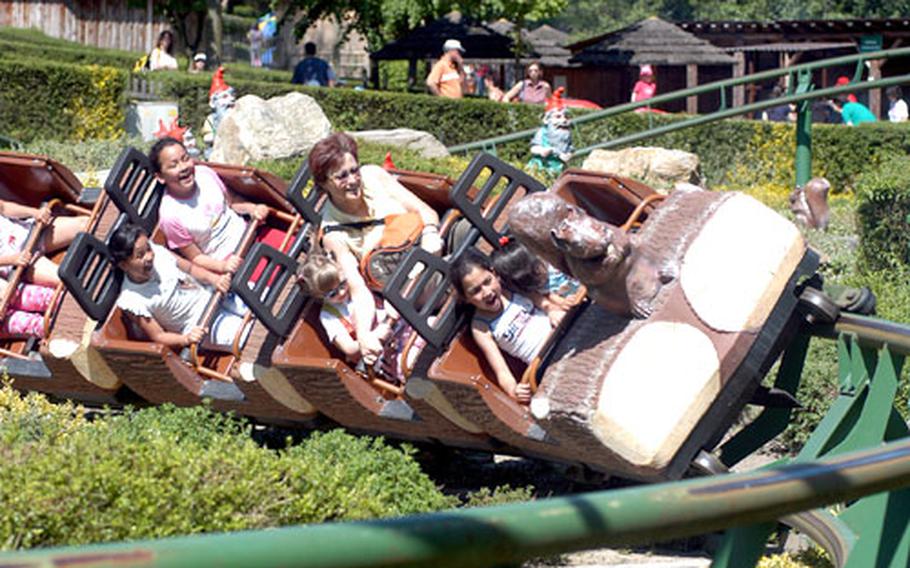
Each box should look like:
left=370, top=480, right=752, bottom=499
left=61, top=148, right=317, bottom=423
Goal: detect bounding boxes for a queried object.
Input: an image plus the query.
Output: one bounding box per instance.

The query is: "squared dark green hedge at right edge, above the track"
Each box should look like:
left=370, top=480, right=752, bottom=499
left=857, top=157, right=910, bottom=271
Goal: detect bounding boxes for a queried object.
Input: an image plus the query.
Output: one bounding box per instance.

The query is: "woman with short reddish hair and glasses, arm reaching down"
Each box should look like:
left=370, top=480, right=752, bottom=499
left=309, top=133, right=442, bottom=365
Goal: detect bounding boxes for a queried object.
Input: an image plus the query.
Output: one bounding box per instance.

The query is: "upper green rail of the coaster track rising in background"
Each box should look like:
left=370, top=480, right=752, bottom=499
left=448, top=47, right=910, bottom=155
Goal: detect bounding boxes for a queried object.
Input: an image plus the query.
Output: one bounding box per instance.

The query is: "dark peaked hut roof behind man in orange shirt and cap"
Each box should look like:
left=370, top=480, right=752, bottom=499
left=370, top=12, right=514, bottom=60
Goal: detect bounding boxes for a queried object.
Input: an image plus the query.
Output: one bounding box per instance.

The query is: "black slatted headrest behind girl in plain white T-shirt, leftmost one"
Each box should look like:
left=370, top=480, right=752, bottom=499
left=58, top=229, right=123, bottom=322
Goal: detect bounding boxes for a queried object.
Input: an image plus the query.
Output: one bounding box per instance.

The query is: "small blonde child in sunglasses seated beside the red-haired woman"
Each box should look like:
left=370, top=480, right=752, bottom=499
left=298, top=252, right=419, bottom=382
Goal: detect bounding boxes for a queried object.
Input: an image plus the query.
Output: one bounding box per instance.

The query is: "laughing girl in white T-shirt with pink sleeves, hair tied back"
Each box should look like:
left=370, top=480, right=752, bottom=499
left=149, top=138, right=268, bottom=274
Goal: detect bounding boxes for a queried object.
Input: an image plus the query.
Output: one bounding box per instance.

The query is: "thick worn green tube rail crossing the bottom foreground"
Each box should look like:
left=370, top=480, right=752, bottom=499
left=0, top=439, right=910, bottom=568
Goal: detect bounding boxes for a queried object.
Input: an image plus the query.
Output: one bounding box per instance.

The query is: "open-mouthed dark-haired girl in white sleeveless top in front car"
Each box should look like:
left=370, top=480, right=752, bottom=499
left=451, top=249, right=564, bottom=404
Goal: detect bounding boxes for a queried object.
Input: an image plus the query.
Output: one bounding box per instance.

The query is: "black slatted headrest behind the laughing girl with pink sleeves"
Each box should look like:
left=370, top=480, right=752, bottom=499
left=104, top=146, right=164, bottom=235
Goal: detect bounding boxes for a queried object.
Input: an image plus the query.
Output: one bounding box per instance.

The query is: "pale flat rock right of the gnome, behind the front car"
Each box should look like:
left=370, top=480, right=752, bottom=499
left=582, top=147, right=699, bottom=190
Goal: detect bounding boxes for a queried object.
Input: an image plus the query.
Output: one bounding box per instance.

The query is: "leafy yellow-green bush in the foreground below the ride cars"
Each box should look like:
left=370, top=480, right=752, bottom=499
left=0, top=386, right=455, bottom=549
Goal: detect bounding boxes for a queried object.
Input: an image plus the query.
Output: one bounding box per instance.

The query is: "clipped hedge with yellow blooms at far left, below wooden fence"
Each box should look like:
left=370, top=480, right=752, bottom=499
left=0, top=59, right=127, bottom=142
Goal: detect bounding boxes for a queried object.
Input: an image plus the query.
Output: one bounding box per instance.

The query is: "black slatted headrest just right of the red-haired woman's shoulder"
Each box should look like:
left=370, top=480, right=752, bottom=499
left=451, top=152, right=547, bottom=250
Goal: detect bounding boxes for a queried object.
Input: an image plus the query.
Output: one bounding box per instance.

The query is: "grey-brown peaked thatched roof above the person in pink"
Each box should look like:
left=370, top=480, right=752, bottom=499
left=567, top=17, right=735, bottom=65
